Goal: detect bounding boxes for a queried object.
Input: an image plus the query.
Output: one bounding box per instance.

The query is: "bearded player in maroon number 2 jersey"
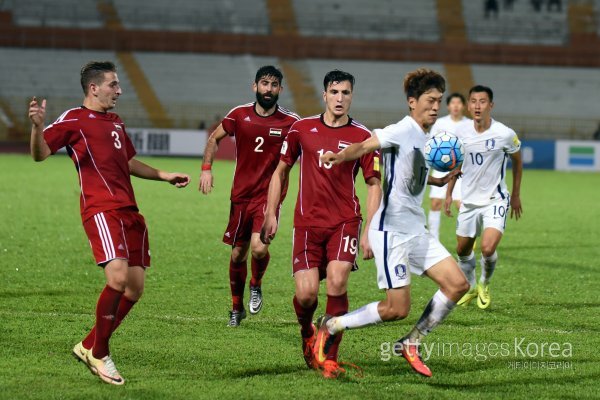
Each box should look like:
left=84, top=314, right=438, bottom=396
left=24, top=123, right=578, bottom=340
left=199, top=65, right=300, bottom=327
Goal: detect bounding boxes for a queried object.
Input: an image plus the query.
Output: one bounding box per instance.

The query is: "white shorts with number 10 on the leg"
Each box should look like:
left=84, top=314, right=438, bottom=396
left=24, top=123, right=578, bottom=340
left=456, top=196, right=510, bottom=238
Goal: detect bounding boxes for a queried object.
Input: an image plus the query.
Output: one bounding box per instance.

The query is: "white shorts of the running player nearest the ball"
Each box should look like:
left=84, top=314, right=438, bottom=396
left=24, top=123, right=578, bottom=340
left=369, top=229, right=450, bottom=289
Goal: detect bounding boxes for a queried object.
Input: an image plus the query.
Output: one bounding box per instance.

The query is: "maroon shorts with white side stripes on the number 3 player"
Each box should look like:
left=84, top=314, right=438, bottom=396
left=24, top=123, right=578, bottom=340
left=83, top=208, right=150, bottom=268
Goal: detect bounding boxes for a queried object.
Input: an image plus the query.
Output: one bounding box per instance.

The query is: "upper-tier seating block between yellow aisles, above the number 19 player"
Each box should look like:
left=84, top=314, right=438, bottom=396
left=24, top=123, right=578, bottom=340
left=294, top=0, right=440, bottom=42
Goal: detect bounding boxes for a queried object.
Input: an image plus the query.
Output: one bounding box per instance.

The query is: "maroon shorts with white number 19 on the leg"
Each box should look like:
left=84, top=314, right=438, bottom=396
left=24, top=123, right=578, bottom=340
left=292, top=220, right=361, bottom=279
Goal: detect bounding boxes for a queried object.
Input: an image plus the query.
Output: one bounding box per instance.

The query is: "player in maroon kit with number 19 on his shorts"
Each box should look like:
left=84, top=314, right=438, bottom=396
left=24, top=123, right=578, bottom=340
left=261, top=70, right=381, bottom=378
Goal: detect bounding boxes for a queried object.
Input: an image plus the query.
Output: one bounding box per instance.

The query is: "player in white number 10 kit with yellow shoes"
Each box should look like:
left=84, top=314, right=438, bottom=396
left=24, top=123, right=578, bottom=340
left=444, top=85, right=523, bottom=309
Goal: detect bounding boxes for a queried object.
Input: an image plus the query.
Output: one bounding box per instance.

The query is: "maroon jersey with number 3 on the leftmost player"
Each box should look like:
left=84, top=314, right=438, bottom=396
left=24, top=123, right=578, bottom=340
left=44, top=107, right=137, bottom=221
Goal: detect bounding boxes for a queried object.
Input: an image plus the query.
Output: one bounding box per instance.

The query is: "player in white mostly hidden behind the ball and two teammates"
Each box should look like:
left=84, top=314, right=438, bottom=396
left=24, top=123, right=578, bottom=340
left=427, top=93, right=468, bottom=239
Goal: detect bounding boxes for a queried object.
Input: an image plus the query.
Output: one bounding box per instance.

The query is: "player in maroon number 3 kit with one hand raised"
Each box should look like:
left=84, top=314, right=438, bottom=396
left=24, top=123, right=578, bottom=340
left=29, top=61, right=189, bottom=385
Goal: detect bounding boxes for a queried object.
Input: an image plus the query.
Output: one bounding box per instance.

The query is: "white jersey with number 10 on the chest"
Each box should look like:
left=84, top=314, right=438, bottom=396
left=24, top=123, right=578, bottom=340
left=456, top=119, right=521, bottom=206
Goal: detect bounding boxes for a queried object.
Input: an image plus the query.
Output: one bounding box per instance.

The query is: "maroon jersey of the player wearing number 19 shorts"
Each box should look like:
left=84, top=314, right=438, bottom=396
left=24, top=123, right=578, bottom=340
left=281, top=115, right=381, bottom=227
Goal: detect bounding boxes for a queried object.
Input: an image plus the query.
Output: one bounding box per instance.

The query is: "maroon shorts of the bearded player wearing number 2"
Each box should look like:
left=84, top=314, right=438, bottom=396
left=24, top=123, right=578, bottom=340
left=223, top=202, right=279, bottom=246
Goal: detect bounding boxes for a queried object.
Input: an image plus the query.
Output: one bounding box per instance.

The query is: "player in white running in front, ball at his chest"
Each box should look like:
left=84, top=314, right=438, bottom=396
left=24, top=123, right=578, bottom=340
left=315, top=69, right=468, bottom=376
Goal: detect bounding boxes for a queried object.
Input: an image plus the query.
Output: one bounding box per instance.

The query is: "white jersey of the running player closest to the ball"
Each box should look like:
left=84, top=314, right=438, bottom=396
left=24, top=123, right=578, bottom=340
left=370, top=116, right=430, bottom=235
